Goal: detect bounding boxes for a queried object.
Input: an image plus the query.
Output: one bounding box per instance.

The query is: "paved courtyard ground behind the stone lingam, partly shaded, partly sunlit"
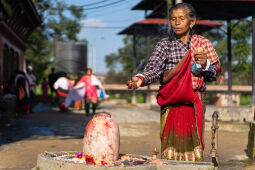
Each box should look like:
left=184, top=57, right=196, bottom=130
left=0, top=103, right=255, bottom=170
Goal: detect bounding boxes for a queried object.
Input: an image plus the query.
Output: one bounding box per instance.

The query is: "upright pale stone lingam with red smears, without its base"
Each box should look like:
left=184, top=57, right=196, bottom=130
left=83, top=113, right=120, bottom=161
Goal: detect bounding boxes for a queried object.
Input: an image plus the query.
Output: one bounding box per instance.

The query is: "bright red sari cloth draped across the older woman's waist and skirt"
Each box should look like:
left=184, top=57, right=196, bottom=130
left=157, top=52, right=204, bottom=148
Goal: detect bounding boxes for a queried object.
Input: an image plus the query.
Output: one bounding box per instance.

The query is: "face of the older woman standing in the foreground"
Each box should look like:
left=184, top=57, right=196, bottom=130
left=170, top=8, right=196, bottom=36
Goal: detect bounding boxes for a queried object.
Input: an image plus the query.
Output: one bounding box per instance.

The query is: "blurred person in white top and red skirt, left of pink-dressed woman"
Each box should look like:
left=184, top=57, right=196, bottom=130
left=54, top=72, right=73, bottom=111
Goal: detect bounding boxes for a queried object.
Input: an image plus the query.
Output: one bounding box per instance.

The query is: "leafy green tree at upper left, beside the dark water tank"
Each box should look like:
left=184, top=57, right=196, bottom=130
left=25, top=0, right=85, bottom=79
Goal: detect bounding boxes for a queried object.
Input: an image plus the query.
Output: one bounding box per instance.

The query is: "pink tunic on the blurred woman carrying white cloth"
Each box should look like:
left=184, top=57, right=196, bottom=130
left=81, top=75, right=98, bottom=103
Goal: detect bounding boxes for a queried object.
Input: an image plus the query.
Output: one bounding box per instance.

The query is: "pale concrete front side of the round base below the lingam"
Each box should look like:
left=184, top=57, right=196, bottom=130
left=32, top=152, right=214, bottom=170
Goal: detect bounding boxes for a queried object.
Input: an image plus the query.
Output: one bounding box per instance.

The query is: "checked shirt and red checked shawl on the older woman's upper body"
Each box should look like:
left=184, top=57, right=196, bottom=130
left=138, top=35, right=221, bottom=91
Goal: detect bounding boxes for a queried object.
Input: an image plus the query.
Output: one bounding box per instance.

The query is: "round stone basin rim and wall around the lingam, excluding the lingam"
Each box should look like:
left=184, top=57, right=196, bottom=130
left=32, top=151, right=214, bottom=170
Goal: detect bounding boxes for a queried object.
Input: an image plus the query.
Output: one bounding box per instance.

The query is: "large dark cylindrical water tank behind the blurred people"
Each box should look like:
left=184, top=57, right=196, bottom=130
left=56, top=41, right=87, bottom=74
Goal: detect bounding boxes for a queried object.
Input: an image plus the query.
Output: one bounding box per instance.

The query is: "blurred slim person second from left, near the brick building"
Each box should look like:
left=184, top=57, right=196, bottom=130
left=26, top=66, right=37, bottom=112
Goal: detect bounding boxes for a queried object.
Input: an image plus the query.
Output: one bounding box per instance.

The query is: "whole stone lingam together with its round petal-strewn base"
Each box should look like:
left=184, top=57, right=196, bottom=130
left=33, top=113, right=214, bottom=170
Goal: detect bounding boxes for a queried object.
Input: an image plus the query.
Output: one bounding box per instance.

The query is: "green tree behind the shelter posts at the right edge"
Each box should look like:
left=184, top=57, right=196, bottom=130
left=204, top=18, right=252, bottom=85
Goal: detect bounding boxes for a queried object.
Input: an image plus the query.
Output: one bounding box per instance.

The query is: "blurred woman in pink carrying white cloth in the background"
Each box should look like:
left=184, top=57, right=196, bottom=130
left=80, top=68, right=103, bottom=116
